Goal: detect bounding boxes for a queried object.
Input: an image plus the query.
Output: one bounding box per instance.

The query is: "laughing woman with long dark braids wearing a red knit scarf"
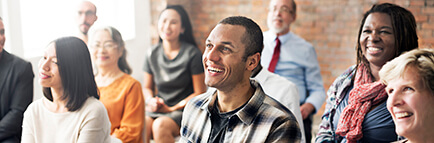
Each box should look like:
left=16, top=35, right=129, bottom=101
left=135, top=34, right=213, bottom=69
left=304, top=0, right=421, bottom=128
left=316, top=3, right=418, bottom=142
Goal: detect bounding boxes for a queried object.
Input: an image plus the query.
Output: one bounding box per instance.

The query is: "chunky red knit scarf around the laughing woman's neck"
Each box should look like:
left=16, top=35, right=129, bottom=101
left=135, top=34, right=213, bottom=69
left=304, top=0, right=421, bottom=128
left=336, top=64, right=387, bottom=143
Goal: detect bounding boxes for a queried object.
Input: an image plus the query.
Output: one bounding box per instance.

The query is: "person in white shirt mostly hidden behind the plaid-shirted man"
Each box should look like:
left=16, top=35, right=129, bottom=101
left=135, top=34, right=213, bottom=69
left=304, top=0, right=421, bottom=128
left=251, top=64, right=306, bottom=142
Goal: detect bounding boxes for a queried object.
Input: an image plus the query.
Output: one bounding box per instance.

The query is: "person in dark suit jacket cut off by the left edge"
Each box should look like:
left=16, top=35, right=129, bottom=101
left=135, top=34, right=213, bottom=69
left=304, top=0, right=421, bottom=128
left=0, top=17, right=34, bottom=143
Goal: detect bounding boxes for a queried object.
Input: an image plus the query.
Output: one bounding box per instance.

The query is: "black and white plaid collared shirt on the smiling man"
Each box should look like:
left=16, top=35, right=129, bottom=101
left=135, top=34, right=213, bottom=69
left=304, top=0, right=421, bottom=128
left=179, top=80, right=301, bottom=143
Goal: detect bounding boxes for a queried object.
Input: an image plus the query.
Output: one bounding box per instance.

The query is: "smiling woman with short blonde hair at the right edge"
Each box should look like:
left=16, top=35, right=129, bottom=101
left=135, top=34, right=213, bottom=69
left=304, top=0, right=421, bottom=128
left=380, top=49, right=434, bottom=143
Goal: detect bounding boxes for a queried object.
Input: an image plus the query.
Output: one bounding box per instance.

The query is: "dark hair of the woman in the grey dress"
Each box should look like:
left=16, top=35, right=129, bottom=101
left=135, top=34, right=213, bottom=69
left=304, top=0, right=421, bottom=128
left=160, top=5, right=197, bottom=47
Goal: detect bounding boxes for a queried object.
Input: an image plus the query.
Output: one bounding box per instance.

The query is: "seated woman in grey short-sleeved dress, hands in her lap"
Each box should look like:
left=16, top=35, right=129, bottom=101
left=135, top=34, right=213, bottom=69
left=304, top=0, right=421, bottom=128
left=143, top=5, right=206, bottom=142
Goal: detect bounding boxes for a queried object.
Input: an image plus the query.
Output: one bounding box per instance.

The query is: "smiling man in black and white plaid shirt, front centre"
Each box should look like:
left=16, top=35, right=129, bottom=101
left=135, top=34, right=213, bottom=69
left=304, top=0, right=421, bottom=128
left=180, top=16, right=301, bottom=143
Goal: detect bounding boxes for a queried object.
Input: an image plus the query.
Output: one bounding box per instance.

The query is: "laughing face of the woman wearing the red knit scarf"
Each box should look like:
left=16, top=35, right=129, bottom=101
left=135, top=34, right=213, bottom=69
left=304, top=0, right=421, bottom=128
left=359, top=12, right=396, bottom=67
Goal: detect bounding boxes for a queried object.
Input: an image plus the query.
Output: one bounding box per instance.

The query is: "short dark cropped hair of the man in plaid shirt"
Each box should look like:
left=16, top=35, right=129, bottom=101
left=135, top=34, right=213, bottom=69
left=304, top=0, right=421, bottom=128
left=219, top=16, right=264, bottom=61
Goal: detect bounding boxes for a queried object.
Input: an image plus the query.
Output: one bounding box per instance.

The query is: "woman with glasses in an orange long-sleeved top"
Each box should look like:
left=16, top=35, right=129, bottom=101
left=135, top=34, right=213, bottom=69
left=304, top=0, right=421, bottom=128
left=89, top=27, right=145, bottom=143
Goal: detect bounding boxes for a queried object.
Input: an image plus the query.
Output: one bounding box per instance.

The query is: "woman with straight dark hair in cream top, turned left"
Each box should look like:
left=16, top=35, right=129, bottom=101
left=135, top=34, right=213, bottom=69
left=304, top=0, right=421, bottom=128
left=22, top=37, right=110, bottom=143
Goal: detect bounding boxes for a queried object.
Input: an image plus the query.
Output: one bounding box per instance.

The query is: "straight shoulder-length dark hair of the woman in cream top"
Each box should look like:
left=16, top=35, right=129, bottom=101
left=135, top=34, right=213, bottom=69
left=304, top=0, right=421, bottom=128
left=43, top=37, right=99, bottom=112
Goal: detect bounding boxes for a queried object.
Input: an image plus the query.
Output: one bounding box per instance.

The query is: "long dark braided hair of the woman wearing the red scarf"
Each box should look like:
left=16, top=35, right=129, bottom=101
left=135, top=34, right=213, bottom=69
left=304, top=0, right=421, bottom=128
left=355, top=3, right=419, bottom=75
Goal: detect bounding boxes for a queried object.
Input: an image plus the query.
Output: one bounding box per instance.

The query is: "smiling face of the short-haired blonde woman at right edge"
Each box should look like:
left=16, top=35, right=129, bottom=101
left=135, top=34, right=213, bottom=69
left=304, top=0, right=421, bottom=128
left=386, top=67, right=434, bottom=140
